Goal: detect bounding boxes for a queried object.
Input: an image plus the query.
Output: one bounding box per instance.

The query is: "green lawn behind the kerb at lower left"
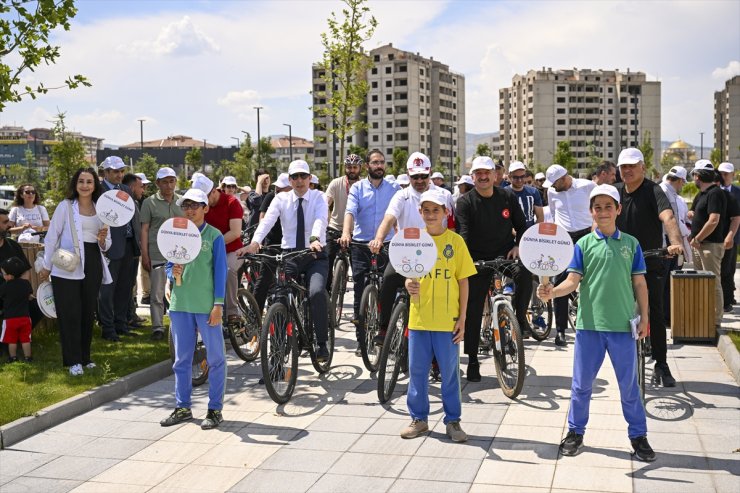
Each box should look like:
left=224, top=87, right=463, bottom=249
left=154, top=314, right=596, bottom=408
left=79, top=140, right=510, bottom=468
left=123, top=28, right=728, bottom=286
left=0, top=320, right=169, bottom=425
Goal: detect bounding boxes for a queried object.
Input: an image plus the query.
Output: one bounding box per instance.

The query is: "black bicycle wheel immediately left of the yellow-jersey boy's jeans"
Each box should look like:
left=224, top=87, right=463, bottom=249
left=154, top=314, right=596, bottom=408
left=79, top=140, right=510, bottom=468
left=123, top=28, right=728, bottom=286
left=378, top=302, right=408, bottom=403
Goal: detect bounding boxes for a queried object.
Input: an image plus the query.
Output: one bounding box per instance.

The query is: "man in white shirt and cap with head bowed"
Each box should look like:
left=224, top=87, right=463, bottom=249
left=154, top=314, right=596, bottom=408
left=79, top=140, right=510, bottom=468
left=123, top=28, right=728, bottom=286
left=543, top=164, right=596, bottom=346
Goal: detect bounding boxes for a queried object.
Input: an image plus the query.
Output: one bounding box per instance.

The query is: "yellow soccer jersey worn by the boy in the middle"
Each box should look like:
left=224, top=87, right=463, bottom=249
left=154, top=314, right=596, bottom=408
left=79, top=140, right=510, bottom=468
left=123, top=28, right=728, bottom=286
left=409, top=229, right=477, bottom=332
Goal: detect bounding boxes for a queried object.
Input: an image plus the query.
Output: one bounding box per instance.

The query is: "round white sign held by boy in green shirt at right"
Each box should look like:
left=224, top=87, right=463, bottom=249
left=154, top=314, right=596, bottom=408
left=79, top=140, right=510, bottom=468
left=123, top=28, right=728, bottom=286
left=519, top=223, right=574, bottom=277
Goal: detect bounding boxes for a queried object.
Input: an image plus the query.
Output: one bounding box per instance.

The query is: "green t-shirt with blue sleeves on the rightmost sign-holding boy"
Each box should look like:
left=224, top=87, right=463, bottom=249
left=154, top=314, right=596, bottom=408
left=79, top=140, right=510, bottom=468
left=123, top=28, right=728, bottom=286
left=568, top=229, right=645, bottom=332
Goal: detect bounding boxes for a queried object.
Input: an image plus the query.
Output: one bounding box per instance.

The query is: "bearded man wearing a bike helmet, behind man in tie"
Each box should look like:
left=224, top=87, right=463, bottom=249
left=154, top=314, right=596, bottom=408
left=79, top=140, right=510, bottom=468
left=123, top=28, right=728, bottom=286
left=326, top=154, right=362, bottom=291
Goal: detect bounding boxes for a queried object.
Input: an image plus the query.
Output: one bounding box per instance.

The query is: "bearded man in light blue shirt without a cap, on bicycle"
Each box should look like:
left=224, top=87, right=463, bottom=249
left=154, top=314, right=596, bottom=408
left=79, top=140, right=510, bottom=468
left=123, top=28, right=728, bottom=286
left=342, top=149, right=399, bottom=350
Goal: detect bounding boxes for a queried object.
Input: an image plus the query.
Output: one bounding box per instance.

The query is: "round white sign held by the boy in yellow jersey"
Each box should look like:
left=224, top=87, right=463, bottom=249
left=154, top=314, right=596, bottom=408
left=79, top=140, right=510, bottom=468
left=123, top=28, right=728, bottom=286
left=388, top=228, right=437, bottom=278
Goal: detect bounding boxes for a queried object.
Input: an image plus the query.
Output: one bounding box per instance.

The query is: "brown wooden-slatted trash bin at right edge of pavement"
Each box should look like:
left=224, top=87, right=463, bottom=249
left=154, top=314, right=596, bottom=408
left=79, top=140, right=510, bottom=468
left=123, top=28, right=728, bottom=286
left=671, top=270, right=717, bottom=342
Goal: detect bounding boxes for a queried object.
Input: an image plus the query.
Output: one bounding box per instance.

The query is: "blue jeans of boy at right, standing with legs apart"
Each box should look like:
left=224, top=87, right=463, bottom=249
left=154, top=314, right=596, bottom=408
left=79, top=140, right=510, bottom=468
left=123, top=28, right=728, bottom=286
left=568, top=329, right=647, bottom=439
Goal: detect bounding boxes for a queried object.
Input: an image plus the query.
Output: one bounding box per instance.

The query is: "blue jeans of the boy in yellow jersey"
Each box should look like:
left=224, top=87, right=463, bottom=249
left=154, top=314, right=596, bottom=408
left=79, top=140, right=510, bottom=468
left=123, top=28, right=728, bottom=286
left=406, top=330, right=462, bottom=424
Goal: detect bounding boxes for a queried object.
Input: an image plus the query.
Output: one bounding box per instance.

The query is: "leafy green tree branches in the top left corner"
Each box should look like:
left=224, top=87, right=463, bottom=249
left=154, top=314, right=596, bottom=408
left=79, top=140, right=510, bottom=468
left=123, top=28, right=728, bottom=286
left=0, top=0, right=91, bottom=111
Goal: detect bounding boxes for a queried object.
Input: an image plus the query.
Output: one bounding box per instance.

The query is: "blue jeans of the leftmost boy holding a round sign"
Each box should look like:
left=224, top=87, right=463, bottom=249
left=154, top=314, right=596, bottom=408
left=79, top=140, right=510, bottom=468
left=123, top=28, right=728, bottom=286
left=170, top=312, right=226, bottom=411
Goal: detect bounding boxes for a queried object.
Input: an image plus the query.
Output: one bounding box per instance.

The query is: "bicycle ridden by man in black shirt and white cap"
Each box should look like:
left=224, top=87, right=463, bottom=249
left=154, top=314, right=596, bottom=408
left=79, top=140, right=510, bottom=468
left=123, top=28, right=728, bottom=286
left=475, top=258, right=525, bottom=399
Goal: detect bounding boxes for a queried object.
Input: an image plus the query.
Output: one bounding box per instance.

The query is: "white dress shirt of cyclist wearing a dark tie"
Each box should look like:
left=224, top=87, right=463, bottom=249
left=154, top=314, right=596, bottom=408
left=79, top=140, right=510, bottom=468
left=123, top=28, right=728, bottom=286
left=252, top=190, right=329, bottom=249
